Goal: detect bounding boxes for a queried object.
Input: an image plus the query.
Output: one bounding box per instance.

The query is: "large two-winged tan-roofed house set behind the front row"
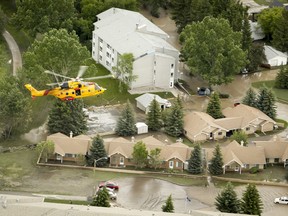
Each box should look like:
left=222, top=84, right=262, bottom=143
left=183, top=104, right=276, bottom=142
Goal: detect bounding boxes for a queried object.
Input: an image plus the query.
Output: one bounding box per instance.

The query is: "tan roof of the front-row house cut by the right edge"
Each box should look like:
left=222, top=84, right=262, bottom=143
left=254, top=141, right=288, bottom=161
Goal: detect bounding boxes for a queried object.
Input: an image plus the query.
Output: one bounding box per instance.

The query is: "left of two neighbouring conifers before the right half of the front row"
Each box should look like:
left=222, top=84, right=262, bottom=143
left=188, top=143, right=203, bottom=174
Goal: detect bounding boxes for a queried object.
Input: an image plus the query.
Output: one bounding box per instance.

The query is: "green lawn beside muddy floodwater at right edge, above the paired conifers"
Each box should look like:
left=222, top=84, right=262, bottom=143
left=252, top=80, right=288, bottom=104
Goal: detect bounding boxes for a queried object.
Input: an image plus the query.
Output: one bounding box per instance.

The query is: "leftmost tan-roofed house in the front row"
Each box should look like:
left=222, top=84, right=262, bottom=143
left=47, top=133, right=91, bottom=163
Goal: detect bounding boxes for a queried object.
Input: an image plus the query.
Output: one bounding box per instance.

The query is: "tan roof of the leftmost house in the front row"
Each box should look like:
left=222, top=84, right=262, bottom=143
left=47, top=133, right=91, bottom=156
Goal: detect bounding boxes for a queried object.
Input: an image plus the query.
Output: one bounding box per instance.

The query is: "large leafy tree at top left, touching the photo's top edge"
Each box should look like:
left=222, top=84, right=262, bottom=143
left=12, top=0, right=75, bottom=36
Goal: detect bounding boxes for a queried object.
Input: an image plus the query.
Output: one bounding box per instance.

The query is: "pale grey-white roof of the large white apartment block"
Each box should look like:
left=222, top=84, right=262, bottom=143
left=94, top=8, right=178, bottom=57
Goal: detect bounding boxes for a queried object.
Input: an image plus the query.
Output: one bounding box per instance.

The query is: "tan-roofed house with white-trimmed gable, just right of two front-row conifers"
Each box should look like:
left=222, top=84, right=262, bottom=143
left=204, top=141, right=266, bottom=174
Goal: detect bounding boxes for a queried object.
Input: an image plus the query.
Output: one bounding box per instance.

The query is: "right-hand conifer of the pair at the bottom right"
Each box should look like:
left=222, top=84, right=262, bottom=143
left=241, top=184, right=263, bottom=216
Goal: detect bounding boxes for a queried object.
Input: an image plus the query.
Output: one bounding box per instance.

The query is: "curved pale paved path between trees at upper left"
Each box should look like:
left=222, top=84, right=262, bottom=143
left=3, top=31, right=22, bottom=76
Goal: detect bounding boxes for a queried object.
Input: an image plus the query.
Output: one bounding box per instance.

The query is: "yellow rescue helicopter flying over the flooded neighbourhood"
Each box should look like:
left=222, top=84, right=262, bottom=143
left=25, top=66, right=112, bottom=100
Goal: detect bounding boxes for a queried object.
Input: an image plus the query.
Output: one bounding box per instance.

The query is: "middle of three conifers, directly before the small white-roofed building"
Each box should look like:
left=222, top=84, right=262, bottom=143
left=147, top=98, right=162, bottom=131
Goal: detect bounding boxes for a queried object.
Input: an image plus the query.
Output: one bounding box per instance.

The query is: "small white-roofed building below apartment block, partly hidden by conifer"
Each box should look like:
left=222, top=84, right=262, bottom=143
left=136, top=93, right=170, bottom=114
